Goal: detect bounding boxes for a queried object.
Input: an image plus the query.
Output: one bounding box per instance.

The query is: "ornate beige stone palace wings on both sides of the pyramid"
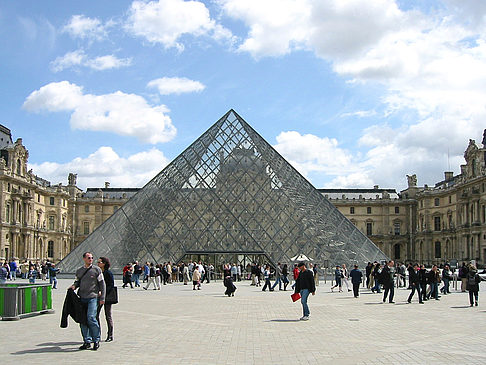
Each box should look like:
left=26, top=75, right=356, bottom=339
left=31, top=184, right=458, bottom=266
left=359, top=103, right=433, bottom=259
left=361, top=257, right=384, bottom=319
left=0, top=125, right=486, bottom=265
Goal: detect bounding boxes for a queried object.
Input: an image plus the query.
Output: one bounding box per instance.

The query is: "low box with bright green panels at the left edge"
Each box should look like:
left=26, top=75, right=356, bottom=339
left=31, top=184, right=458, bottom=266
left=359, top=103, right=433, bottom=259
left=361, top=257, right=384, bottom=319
left=0, top=283, right=54, bottom=321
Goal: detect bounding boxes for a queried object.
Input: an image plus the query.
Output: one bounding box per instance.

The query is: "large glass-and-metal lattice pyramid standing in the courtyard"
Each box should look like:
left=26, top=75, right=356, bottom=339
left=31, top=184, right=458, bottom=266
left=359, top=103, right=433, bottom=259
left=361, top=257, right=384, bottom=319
left=59, top=110, right=386, bottom=273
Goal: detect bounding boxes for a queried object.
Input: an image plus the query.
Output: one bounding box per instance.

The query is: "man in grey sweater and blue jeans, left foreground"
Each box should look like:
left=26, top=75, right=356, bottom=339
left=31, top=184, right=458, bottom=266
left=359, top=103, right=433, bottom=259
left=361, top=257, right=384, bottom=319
left=68, top=252, right=106, bottom=351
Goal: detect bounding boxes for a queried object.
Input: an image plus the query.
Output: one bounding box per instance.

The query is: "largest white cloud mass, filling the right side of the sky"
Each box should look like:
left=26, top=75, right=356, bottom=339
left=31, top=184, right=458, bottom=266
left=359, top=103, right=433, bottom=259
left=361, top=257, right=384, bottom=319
left=218, top=0, right=486, bottom=187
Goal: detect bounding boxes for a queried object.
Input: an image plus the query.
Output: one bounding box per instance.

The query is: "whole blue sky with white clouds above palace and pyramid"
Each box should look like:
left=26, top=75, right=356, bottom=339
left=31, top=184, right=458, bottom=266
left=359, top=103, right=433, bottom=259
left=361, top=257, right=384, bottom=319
left=0, top=0, right=486, bottom=190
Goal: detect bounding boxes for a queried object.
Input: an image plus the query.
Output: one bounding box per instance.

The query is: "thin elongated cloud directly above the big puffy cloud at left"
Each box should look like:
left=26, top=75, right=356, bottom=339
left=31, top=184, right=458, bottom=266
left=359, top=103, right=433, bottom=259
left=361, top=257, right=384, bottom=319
left=51, top=49, right=132, bottom=72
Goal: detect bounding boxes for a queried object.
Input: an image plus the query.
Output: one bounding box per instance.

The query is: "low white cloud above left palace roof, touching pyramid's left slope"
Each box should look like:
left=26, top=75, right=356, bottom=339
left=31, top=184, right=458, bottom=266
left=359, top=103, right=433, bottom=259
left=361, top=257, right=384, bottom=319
left=29, top=147, right=169, bottom=189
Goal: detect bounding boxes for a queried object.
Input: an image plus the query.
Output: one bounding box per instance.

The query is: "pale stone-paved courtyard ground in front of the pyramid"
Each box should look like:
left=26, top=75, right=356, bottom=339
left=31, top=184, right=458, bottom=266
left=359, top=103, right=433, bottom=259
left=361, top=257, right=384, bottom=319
left=0, top=279, right=486, bottom=365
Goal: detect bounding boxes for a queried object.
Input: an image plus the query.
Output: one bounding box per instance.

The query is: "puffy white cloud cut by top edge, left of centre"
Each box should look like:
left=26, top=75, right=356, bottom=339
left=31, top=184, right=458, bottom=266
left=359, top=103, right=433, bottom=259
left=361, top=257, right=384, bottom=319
left=126, top=0, right=232, bottom=50
